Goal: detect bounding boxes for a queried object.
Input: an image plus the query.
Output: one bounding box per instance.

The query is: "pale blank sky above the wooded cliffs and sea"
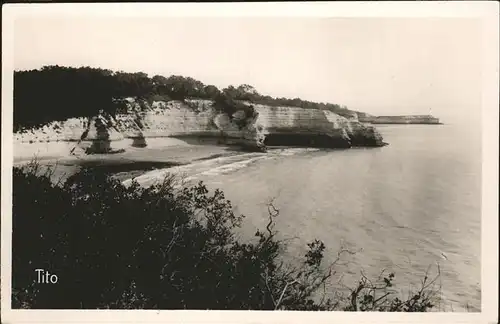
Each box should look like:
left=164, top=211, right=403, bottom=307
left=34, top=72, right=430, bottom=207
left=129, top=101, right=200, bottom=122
left=14, top=16, right=481, bottom=121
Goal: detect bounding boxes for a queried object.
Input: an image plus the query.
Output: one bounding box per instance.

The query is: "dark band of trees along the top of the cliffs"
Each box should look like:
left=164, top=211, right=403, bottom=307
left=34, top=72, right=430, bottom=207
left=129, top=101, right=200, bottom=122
left=14, top=65, right=349, bottom=131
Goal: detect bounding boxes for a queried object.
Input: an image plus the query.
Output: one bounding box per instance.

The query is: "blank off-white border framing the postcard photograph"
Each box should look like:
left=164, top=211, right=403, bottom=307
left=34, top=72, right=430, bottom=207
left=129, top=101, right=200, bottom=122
left=1, top=1, right=500, bottom=324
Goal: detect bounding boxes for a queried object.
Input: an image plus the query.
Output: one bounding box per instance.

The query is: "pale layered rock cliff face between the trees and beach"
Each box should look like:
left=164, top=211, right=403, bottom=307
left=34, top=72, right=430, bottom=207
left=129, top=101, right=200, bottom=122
left=14, top=99, right=385, bottom=156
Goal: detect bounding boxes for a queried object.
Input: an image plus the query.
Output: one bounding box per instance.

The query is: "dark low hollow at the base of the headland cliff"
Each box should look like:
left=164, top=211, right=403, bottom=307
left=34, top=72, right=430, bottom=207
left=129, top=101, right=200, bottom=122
left=264, top=134, right=351, bottom=148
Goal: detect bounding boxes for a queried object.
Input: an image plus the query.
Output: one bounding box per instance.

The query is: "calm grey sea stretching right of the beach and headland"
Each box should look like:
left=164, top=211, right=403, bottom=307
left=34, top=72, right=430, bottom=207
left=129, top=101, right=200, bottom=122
left=180, top=125, right=481, bottom=311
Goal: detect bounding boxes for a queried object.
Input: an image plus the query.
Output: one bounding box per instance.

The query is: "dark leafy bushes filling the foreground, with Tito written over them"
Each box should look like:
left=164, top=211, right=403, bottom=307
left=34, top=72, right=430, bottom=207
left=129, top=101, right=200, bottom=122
left=12, top=163, right=436, bottom=312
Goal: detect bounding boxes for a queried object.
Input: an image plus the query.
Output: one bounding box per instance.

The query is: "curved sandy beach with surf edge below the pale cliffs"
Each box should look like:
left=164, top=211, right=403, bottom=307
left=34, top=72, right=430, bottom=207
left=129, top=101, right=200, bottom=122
left=13, top=138, right=390, bottom=183
